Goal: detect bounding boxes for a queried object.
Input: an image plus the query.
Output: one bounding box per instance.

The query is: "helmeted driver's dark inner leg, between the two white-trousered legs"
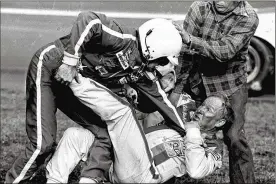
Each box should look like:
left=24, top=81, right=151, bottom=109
left=54, top=82, right=113, bottom=183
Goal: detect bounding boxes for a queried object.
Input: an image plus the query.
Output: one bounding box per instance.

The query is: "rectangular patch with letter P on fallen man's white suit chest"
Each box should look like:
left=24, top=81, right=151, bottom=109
left=164, top=140, right=185, bottom=157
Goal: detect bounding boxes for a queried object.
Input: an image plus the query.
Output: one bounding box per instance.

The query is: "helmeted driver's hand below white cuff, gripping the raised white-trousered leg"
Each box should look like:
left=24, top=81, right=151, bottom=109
left=55, top=63, right=79, bottom=85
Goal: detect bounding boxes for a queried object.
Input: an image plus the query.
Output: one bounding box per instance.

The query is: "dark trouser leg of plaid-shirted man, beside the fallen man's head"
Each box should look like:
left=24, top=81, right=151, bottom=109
left=225, top=85, right=255, bottom=183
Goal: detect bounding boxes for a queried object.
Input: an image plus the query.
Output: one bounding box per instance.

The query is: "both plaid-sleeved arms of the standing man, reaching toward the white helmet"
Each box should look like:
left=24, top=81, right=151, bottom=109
left=183, top=2, right=259, bottom=62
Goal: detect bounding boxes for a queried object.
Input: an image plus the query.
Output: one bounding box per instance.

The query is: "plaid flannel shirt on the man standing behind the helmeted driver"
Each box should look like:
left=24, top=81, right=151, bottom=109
left=174, top=1, right=259, bottom=96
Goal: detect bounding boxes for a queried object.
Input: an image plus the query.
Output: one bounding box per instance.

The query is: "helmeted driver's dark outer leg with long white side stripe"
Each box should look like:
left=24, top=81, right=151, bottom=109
left=5, top=44, right=62, bottom=183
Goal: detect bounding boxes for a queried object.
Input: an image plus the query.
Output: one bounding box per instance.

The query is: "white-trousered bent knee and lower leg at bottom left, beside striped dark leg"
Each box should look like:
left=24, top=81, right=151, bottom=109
left=46, top=127, right=94, bottom=183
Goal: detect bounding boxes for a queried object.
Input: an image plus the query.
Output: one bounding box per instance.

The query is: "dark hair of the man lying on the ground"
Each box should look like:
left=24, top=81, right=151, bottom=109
left=208, top=93, right=234, bottom=131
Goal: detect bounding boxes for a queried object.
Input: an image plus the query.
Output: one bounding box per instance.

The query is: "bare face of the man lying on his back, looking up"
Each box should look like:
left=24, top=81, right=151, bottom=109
left=193, top=97, right=226, bottom=130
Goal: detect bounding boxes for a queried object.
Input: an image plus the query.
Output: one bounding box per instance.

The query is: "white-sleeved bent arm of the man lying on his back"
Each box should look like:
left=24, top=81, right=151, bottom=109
left=185, top=123, right=222, bottom=179
